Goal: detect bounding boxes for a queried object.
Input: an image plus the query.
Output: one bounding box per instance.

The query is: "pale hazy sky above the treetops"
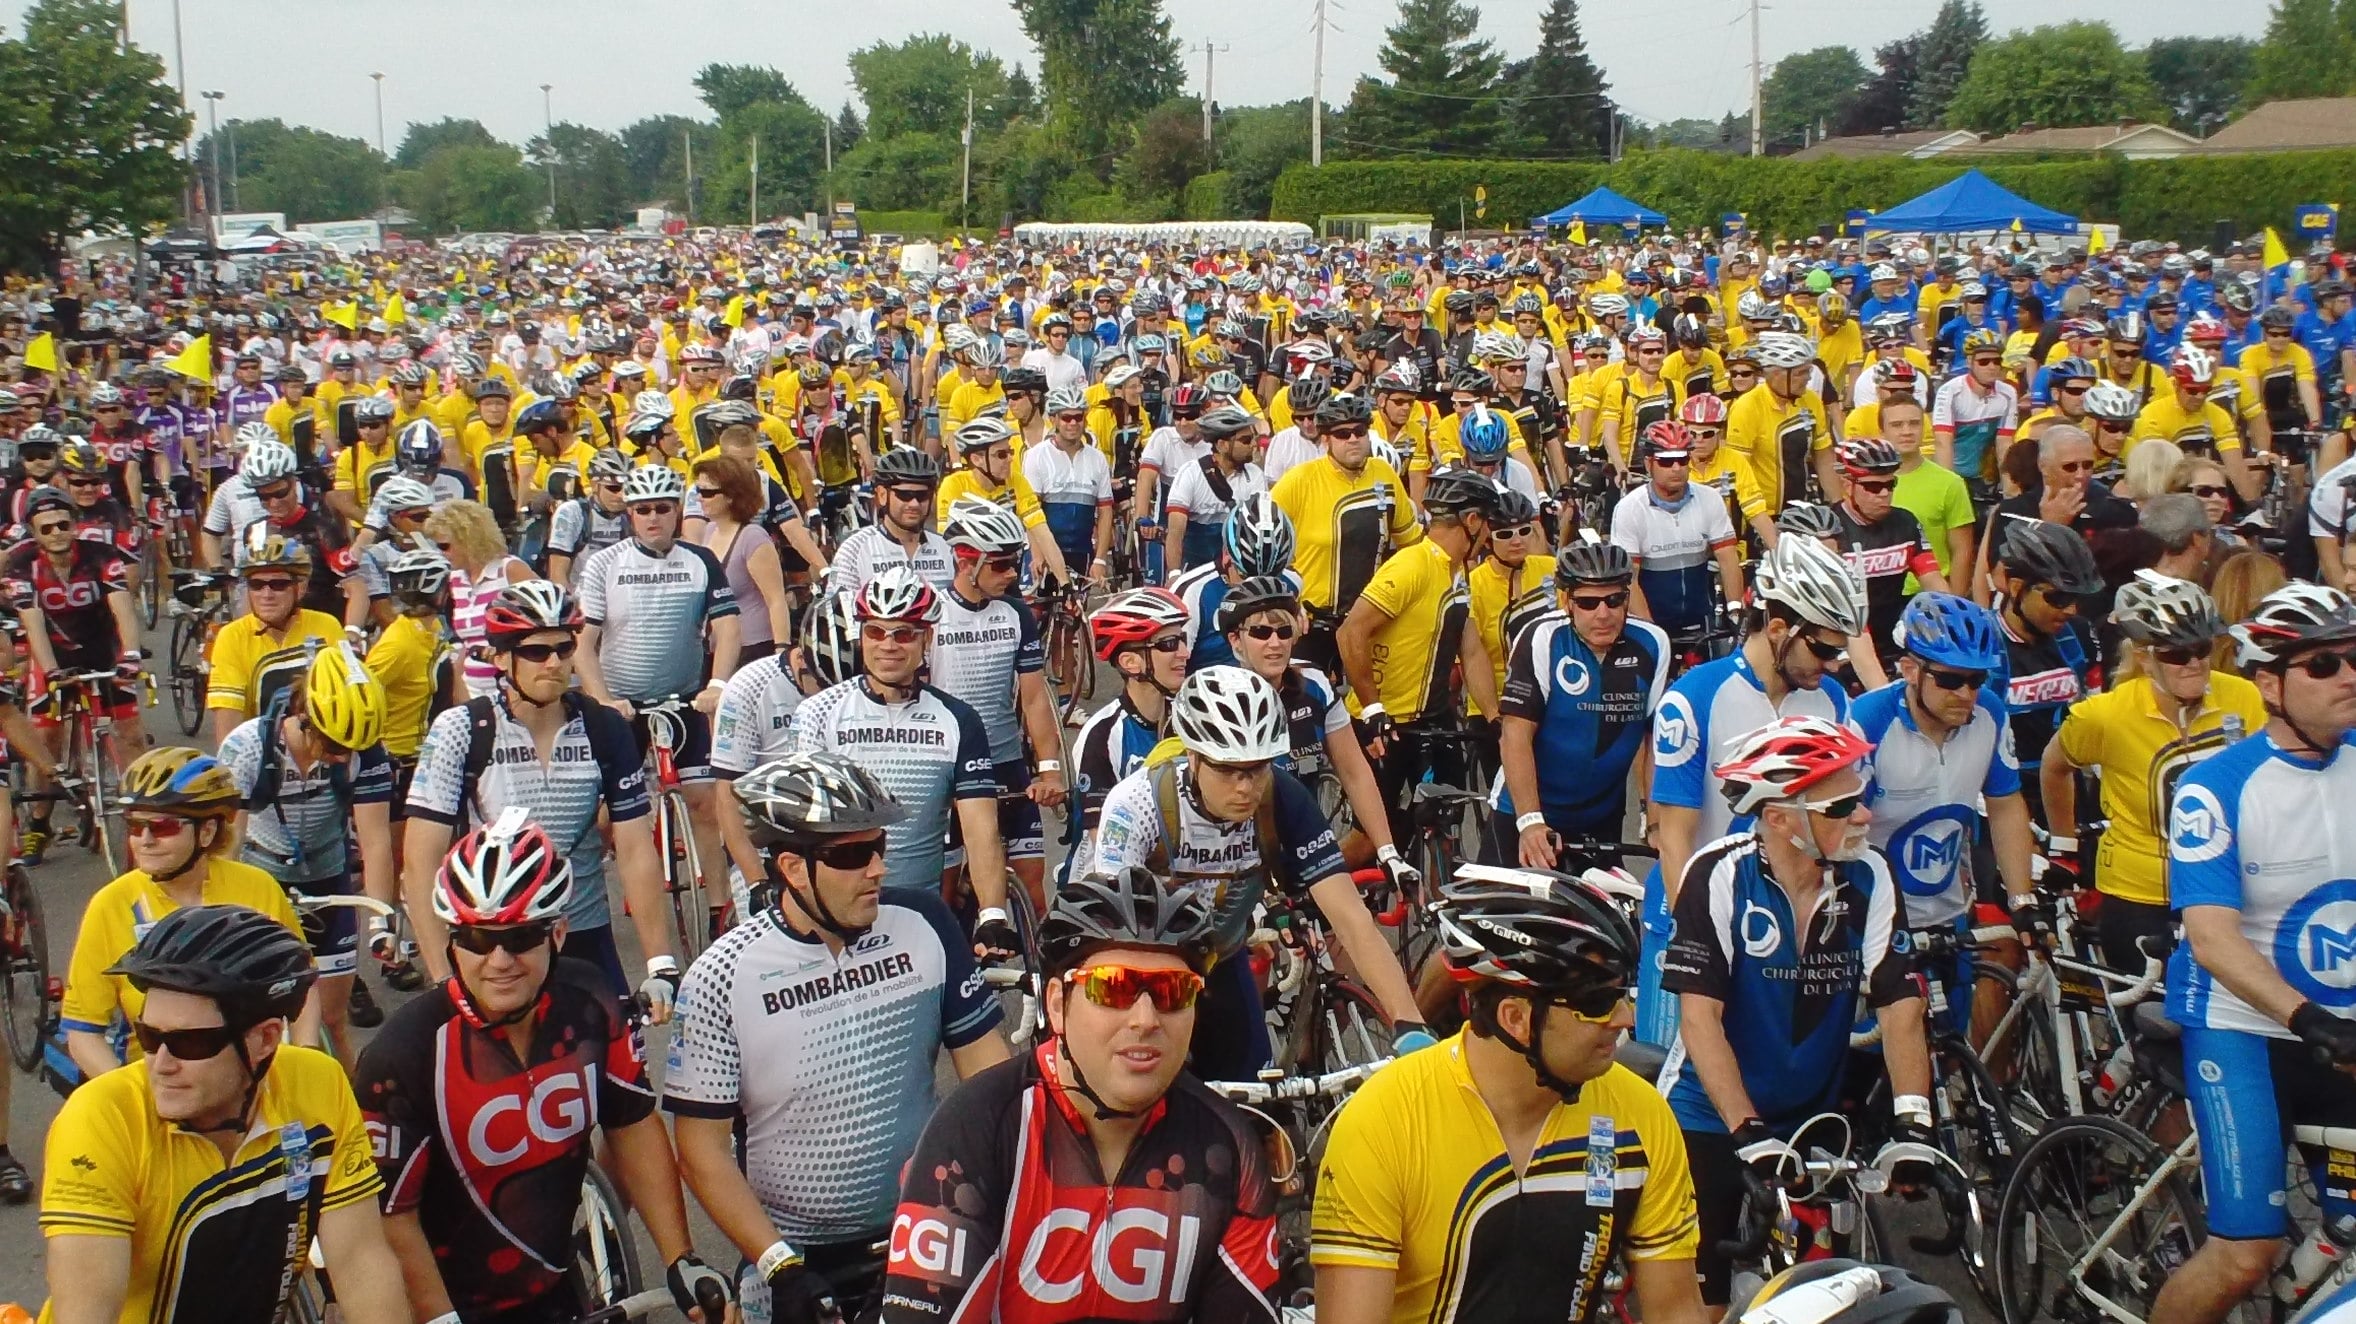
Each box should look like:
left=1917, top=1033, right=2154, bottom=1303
left=0, top=0, right=2271, bottom=148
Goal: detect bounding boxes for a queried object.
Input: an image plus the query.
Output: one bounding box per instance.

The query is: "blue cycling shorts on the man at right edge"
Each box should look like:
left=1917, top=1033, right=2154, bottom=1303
left=2184, top=1025, right=2356, bottom=1242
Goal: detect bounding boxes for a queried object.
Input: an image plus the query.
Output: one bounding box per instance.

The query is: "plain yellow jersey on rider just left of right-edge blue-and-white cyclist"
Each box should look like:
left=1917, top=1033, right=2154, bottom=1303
left=2054, top=671, right=2266, bottom=905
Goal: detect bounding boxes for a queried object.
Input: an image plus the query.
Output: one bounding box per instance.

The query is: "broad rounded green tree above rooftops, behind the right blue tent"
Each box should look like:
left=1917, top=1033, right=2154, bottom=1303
left=1946, top=21, right=2168, bottom=134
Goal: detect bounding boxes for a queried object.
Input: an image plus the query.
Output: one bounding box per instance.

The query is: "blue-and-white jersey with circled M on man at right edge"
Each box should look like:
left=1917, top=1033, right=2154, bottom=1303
left=2168, top=733, right=2356, bottom=1039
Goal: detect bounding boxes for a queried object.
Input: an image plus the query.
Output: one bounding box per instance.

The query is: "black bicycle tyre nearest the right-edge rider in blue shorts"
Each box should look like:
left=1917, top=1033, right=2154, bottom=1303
left=1991, top=1117, right=2208, bottom=1324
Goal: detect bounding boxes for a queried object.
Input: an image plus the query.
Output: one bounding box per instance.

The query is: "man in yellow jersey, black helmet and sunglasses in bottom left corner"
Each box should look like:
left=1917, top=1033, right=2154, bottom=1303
left=40, top=905, right=412, bottom=1324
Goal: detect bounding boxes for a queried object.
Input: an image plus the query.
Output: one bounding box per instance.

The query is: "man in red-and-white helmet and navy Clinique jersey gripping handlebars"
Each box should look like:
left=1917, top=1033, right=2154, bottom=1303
left=1661, top=716, right=1932, bottom=1308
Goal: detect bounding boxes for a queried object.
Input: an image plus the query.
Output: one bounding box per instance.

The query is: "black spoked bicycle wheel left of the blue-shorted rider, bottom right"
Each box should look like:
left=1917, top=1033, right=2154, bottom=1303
left=1991, top=1117, right=2208, bottom=1324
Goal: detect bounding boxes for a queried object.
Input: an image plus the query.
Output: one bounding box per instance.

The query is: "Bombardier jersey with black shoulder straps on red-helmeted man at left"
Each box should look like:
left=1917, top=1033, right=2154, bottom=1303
left=410, top=690, right=648, bottom=933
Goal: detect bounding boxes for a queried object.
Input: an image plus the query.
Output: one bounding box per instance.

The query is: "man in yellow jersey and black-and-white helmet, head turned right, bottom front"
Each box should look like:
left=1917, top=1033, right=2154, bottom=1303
left=1310, top=869, right=1706, bottom=1324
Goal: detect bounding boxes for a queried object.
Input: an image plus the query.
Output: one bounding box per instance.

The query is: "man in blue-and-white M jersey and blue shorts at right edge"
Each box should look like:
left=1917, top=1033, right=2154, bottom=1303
left=2151, top=584, right=2356, bottom=1324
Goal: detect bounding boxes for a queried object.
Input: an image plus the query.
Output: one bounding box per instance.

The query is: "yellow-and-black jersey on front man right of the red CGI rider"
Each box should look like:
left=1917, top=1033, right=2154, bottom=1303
left=1310, top=1032, right=1699, bottom=1324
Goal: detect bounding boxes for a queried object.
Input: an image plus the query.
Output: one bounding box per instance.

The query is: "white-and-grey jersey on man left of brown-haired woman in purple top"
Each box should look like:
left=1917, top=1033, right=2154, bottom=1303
left=577, top=539, right=737, bottom=704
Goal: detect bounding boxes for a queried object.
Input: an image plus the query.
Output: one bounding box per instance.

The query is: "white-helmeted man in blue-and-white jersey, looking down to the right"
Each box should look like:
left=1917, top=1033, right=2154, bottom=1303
left=1635, top=537, right=1866, bottom=1048
